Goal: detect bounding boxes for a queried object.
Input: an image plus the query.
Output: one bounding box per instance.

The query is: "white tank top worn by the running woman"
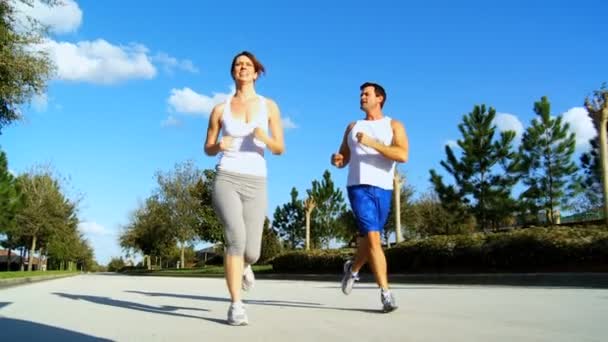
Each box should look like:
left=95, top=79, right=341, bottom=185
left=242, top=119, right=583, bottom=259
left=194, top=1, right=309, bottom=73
left=217, top=95, right=268, bottom=177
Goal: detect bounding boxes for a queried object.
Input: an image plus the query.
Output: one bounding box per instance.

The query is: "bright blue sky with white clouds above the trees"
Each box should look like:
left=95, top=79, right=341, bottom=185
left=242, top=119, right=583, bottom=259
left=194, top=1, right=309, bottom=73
left=0, top=0, right=608, bottom=263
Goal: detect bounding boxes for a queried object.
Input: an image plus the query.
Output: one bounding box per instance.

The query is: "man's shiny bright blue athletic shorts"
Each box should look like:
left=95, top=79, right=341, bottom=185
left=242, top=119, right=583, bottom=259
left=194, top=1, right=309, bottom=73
left=346, top=184, right=393, bottom=236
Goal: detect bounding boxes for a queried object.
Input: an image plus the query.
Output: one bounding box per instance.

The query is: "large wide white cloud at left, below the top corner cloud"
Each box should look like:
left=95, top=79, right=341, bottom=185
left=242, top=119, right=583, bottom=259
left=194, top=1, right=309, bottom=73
left=42, top=39, right=156, bottom=84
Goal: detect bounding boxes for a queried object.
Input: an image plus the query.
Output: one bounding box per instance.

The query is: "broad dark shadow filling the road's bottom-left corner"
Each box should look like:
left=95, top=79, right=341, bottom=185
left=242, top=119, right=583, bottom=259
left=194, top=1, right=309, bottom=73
left=0, top=317, right=111, bottom=342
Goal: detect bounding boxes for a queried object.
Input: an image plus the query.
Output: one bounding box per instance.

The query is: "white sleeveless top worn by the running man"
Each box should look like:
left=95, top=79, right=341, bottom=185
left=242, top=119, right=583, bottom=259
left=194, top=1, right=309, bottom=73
left=347, top=116, right=396, bottom=190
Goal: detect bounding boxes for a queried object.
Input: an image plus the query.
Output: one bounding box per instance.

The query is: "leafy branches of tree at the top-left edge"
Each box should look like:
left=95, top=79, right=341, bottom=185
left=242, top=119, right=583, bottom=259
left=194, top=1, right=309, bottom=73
left=0, top=0, right=57, bottom=134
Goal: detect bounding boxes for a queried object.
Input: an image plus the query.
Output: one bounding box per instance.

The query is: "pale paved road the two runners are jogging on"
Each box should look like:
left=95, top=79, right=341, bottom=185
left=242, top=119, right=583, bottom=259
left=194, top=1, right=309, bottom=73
left=0, top=275, right=608, bottom=342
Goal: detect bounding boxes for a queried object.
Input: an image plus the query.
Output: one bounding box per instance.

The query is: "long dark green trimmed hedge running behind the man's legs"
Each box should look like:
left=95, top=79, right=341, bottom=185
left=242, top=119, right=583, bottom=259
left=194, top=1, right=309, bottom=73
left=270, top=227, right=608, bottom=273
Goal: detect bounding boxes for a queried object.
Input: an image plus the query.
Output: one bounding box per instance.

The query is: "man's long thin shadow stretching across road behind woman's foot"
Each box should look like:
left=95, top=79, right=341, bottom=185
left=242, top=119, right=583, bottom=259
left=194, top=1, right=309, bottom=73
left=126, top=291, right=382, bottom=313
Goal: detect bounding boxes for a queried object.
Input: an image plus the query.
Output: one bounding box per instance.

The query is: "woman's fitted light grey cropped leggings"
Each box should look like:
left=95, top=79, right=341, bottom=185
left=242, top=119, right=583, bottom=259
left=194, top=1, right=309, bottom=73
left=212, top=171, right=268, bottom=264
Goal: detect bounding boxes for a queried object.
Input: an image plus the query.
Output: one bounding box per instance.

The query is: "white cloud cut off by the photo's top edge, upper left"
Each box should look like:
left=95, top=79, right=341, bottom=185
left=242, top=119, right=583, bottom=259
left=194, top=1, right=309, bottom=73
left=13, top=0, right=82, bottom=33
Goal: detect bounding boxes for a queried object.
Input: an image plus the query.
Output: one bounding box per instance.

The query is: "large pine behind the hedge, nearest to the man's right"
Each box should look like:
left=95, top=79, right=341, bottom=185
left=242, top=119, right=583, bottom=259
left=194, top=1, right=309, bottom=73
left=430, top=105, right=518, bottom=229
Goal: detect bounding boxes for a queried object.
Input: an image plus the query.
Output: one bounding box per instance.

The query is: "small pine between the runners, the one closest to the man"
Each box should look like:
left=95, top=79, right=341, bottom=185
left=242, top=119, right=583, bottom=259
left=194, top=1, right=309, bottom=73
left=306, top=170, right=346, bottom=248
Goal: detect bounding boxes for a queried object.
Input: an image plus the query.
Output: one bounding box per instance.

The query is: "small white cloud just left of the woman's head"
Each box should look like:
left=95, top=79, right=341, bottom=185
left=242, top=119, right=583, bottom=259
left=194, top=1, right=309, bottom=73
left=167, top=87, right=234, bottom=115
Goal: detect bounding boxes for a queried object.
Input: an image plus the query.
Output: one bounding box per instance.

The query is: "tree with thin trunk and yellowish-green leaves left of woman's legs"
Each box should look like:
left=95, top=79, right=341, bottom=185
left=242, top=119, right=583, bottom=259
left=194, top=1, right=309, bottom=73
left=157, top=161, right=203, bottom=267
